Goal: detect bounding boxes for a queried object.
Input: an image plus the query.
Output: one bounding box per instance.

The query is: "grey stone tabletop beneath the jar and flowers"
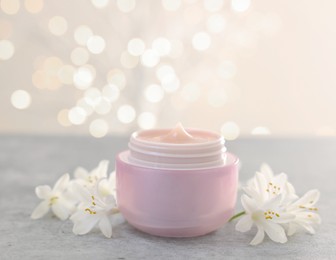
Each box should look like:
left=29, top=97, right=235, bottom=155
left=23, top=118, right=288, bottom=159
left=0, top=136, right=336, bottom=259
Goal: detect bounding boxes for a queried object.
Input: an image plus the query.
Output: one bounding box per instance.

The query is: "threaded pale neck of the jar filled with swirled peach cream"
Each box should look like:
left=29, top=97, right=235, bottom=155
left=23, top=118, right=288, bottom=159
left=128, top=123, right=226, bottom=169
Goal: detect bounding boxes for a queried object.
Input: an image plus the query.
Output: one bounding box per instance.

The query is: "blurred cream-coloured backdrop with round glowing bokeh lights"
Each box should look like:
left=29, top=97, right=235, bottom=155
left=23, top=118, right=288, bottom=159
left=0, top=0, right=336, bottom=140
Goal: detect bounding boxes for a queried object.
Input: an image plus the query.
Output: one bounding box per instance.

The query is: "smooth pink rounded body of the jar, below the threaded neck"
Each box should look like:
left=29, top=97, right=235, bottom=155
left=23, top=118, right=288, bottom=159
left=116, top=150, right=239, bottom=237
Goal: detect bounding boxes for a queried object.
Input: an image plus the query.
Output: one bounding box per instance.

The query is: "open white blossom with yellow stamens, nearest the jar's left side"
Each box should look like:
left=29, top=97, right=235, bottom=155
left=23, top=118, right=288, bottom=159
left=70, top=180, right=119, bottom=238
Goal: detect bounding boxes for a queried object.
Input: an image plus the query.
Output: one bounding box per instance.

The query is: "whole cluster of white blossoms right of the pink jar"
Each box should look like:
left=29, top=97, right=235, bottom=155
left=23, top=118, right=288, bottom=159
left=232, top=164, right=321, bottom=245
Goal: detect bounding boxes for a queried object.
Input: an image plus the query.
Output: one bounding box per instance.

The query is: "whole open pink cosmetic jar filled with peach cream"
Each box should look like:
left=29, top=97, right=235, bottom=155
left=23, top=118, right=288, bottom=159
left=116, top=124, right=239, bottom=237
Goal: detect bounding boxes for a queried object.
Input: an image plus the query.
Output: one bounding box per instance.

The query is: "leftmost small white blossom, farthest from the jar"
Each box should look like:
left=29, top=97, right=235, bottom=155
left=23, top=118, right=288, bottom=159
left=31, top=174, right=74, bottom=220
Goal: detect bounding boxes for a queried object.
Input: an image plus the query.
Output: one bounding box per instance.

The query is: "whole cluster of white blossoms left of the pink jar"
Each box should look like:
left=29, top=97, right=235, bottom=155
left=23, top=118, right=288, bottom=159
left=31, top=160, right=123, bottom=238
